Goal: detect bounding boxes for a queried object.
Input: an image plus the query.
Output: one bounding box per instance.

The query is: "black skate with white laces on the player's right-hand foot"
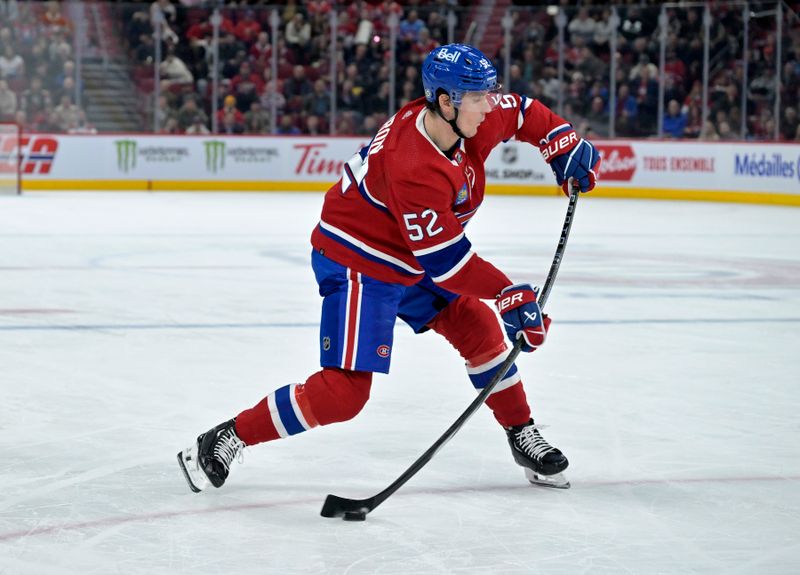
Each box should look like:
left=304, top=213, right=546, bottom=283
left=506, top=419, right=569, bottom=489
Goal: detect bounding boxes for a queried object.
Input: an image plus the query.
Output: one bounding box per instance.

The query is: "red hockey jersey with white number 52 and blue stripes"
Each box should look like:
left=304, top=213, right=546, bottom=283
left=311, top=94, right=567, bottom=299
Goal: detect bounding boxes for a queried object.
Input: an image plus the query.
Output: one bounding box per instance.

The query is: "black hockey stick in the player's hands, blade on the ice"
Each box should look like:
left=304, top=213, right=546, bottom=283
left=320, top=190, right=579, bottom=521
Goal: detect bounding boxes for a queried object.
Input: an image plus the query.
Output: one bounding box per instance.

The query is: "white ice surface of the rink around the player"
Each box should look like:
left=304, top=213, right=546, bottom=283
left=0, top=193, right=800, bottom=575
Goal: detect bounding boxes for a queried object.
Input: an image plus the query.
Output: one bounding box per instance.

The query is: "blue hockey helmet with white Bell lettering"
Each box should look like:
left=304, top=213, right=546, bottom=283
left=422, top=44, right=499, bottom=106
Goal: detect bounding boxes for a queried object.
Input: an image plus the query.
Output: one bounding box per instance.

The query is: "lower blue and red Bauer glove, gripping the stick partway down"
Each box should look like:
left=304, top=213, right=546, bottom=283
left=497, top=284, right=550, bottom=351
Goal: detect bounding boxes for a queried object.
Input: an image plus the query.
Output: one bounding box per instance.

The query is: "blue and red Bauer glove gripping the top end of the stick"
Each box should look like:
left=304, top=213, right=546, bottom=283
left=539, top=124, right=601, bottom=196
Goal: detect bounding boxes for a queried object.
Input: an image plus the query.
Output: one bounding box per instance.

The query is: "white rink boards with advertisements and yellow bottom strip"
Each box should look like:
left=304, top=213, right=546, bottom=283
left=7, top=134, right=800, bottom=205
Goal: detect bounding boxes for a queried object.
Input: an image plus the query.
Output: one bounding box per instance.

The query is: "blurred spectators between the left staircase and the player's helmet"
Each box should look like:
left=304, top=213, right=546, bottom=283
left=119, top=0, right=456, bottom=135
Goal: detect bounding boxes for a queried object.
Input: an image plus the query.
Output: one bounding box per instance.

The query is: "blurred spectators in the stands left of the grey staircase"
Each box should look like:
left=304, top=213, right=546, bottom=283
left=0, top=0, right=94, bottom=133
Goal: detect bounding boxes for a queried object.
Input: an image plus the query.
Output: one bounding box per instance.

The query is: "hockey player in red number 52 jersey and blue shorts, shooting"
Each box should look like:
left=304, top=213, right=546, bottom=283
left=178, top=44, right=600, bottom=491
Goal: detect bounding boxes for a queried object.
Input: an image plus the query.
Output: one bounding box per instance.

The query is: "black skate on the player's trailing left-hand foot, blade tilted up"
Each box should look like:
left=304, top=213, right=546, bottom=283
left=178, top=419, right=245, bottom=493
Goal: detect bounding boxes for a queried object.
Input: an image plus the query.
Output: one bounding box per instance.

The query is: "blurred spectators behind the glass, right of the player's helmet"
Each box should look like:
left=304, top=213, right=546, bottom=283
left=510, top=2, right=800, bottom=141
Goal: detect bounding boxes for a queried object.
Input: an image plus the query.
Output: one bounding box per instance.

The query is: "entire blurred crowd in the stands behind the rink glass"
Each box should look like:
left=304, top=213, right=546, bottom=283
left=0, top=0, right=800, bottom=141
